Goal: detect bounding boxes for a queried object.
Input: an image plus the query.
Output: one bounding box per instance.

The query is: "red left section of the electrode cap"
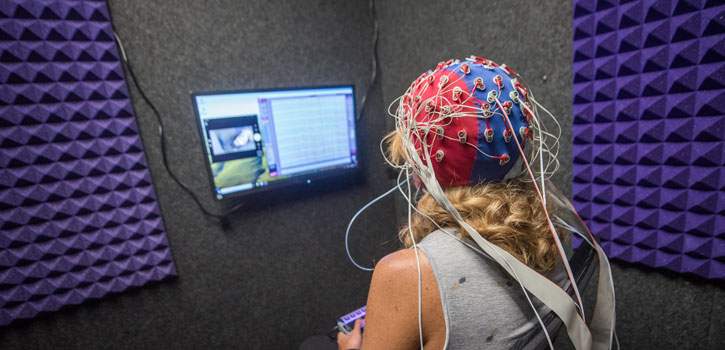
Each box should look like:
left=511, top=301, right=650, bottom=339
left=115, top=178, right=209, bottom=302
left=411, top=69, right=478, bottom=187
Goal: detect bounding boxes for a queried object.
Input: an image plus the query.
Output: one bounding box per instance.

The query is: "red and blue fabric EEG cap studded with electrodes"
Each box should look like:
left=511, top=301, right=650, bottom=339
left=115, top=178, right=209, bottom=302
left=398, top=57, right=533, bottom=187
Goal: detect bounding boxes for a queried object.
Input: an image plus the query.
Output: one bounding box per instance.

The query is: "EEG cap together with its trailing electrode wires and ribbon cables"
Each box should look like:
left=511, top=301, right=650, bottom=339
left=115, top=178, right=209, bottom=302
left=346, top=56, right=615, bottom=349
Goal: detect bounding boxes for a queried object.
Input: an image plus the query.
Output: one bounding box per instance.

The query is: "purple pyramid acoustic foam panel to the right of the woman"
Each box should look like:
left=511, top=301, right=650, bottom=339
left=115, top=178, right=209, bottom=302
left=572, top=0, right=725, bottom=279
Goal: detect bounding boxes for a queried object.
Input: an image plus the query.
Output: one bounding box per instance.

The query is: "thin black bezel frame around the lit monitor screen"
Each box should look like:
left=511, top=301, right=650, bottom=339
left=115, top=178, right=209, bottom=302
left=190, top=84, right=362, bottom=202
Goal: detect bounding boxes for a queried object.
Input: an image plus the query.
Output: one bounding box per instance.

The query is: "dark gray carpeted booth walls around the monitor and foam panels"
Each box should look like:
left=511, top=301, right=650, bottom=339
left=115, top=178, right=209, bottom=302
left=0, top=0, right=725, bottom=349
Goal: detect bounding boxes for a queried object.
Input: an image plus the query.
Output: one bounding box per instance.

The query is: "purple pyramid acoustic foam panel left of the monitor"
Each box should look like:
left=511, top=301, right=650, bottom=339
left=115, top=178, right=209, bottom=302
left=0, top=0, right=176, bottom=325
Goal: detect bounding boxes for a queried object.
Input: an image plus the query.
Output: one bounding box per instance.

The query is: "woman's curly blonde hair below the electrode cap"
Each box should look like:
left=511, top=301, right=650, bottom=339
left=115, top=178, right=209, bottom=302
left=385, top=131, right=568, bottom=273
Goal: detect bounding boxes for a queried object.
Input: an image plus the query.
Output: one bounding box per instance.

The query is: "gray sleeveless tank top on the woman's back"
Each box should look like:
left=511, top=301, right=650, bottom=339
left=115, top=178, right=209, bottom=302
left=418, top=229, right=568, bottom=350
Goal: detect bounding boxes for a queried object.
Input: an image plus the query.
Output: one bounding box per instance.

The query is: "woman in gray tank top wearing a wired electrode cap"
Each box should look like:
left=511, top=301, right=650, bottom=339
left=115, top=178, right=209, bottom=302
left=338, top=57, right=584, bottom=350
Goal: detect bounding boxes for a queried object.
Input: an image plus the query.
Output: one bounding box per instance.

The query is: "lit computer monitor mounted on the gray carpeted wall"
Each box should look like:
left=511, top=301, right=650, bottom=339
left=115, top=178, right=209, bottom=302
left=192, top=86, right=358, bottom=199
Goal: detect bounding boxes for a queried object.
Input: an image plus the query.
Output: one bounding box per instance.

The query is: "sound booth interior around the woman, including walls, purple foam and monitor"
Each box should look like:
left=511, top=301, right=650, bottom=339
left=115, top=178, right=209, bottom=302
left=0, top=0, right=725, bottom=349
